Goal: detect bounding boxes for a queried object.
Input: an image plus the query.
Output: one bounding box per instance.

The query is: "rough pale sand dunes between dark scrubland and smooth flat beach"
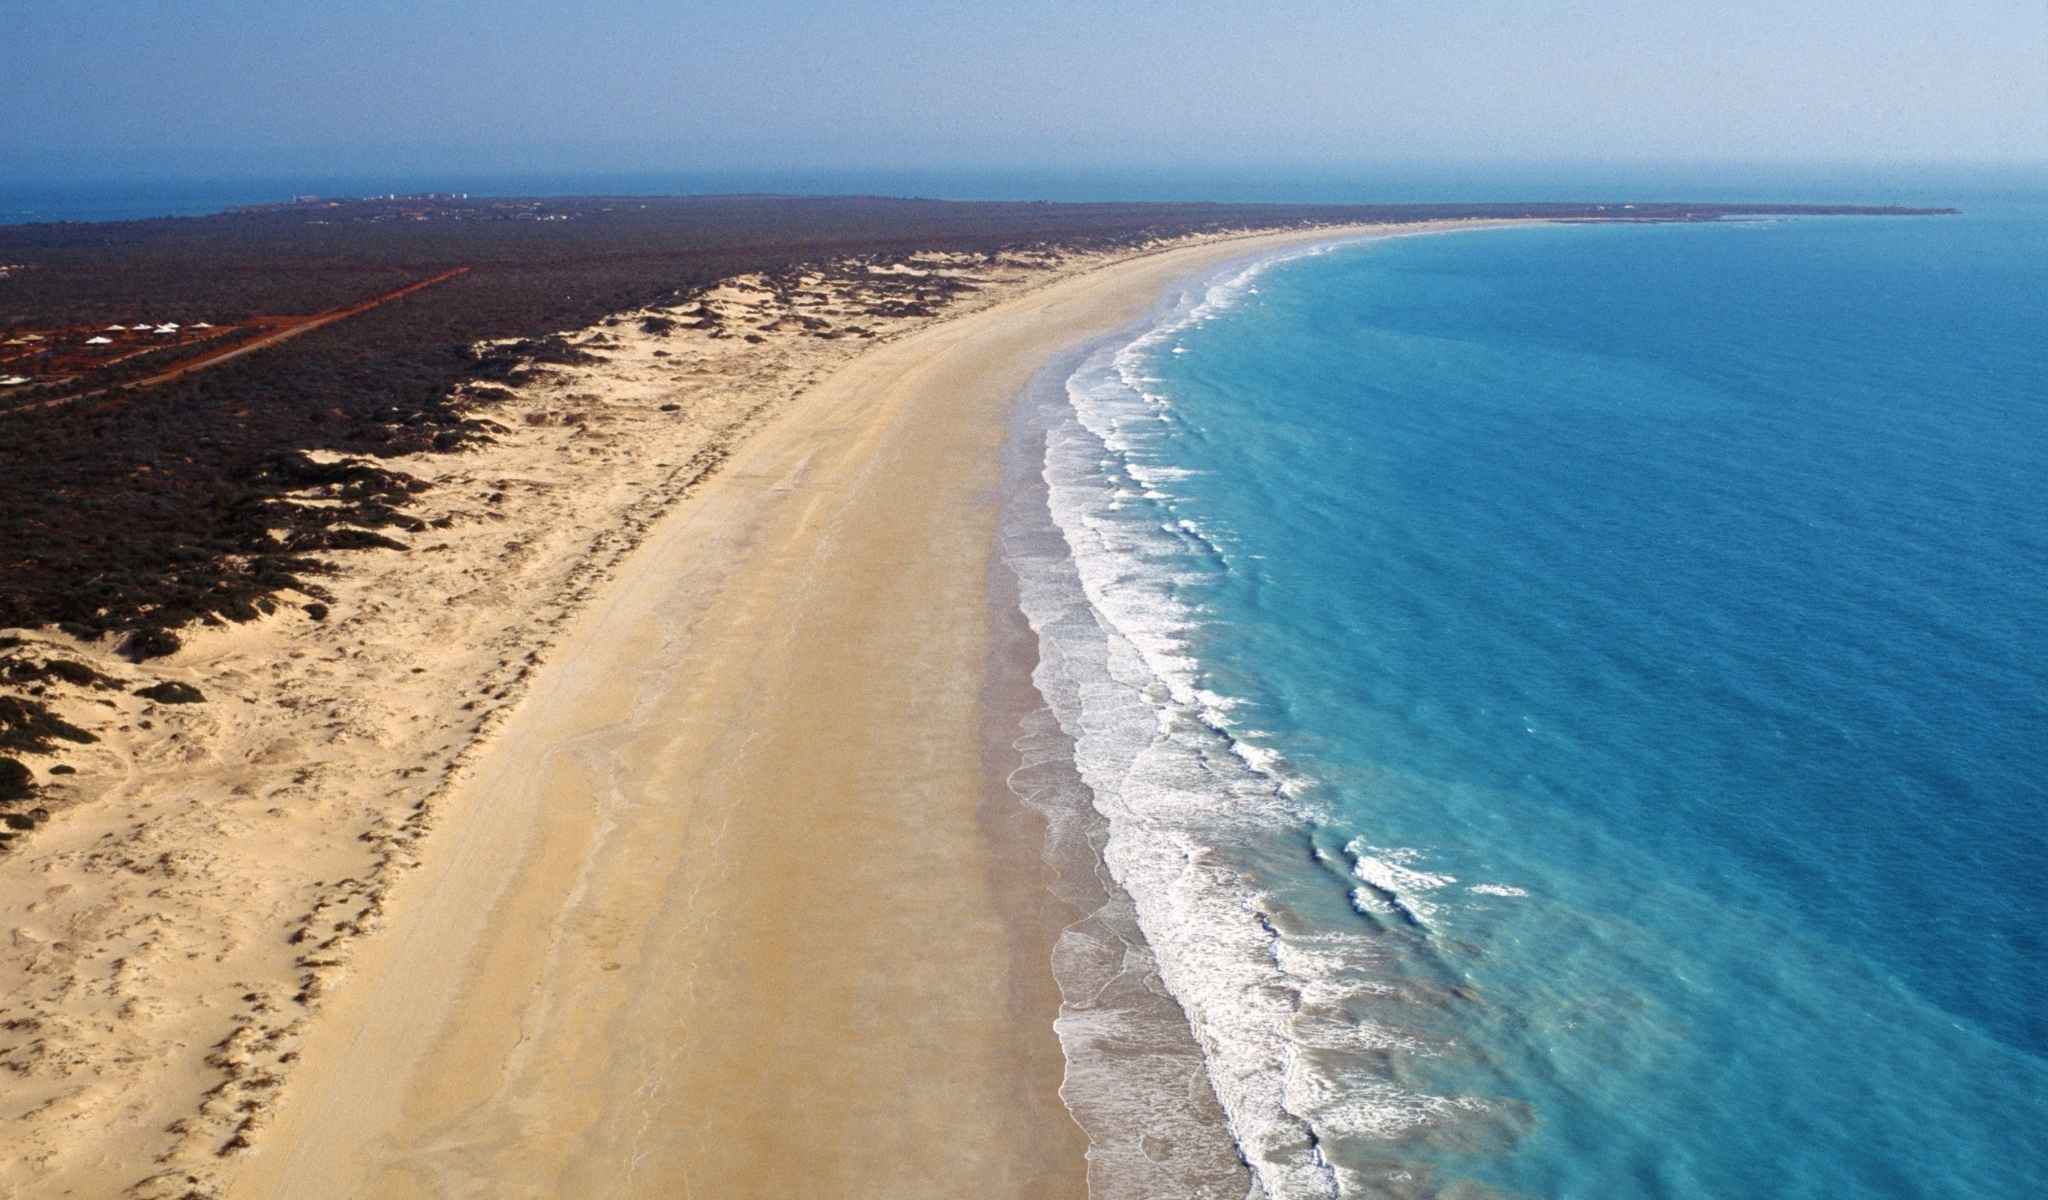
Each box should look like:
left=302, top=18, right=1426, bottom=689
left=0, top=224, right=1327, bottom=1196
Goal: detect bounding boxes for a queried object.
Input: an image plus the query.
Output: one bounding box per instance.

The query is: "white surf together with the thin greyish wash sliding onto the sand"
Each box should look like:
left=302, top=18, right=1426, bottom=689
left=1004, top=225, right=1515, bottom=1200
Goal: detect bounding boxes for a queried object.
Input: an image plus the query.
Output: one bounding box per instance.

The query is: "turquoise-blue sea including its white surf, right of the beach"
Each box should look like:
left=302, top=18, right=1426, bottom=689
left=1018, top=195, right=2048, bottom=1200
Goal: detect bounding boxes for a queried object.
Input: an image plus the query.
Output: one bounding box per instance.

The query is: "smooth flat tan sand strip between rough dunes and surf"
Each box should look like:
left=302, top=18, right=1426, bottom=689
left=231, top=229, right=1409, bottom=1198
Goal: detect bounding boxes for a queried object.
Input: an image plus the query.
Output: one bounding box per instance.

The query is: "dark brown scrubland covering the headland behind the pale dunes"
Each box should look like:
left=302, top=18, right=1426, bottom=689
left=0, top=197, right=1949, bottom=659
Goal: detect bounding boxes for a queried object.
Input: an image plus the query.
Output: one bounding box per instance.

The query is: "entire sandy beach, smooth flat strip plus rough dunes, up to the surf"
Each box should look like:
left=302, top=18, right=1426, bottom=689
left=0, top=225, right=1507, bottom=1198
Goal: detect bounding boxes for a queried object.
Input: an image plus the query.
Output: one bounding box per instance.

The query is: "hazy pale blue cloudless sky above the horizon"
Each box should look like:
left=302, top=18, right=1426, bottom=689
left=0, top=0, right=2048, bottom=178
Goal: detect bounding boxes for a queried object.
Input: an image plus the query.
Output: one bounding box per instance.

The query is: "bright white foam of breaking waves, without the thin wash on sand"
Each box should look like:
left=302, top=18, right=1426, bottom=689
left=1020, top=238, right=1477, bottom=1200
